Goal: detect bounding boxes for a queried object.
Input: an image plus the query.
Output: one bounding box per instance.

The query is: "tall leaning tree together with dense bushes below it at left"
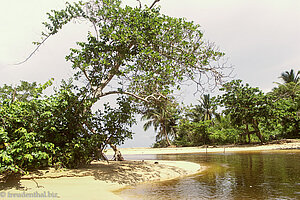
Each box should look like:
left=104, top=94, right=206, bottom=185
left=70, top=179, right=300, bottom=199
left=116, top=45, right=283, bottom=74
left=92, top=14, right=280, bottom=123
left=0, top=0, right=225, bottom=180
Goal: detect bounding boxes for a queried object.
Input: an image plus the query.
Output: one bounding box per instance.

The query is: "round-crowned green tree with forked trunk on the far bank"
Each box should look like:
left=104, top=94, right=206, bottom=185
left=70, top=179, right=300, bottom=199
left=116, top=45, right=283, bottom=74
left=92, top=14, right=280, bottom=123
left=219, top=80, right=272, bottom=143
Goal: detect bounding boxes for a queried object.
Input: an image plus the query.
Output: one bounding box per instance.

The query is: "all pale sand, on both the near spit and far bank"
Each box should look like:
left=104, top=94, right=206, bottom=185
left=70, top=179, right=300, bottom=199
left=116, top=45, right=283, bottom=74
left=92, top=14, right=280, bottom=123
left=0, top=140, right=300, bottom=200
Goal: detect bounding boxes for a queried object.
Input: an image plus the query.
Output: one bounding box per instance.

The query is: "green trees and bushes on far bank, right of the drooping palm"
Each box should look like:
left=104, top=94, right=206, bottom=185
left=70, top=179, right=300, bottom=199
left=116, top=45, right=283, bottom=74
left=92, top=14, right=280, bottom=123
left=175, top=77, right=300, bottom=146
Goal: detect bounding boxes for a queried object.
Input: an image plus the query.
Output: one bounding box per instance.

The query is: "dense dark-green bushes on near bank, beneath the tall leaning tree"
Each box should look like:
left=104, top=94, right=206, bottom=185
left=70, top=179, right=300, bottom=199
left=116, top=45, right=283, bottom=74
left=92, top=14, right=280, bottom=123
left=0, top=81, right=135, bottom=175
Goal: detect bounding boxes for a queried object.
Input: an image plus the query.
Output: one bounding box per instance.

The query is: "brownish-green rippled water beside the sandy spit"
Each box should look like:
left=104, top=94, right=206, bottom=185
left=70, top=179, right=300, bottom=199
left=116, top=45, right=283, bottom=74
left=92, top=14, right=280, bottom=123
left=119, top=150, right=300, bottom=200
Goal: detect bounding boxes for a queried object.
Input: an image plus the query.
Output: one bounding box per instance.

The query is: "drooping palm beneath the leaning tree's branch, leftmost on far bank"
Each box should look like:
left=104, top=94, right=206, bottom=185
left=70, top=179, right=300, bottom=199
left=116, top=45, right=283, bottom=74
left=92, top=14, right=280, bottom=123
left=141, top=102, right=177, bottom=146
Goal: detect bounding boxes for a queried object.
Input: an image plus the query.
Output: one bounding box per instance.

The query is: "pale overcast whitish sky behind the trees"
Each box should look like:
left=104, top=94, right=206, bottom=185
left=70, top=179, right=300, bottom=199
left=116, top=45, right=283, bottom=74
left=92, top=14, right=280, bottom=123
left=0, top=0, right=300, bottom=147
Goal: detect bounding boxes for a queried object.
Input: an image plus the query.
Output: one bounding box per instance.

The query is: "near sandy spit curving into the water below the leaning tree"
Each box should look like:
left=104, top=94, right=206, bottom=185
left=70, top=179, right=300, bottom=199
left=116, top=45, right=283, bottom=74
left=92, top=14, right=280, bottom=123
left=0, top=160, right=206, bottom=200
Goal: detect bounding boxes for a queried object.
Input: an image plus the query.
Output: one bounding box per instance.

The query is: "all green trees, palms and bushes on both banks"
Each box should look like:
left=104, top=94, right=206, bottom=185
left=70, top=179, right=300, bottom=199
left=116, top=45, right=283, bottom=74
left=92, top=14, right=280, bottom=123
left=0, top=0, right=300, bottom=181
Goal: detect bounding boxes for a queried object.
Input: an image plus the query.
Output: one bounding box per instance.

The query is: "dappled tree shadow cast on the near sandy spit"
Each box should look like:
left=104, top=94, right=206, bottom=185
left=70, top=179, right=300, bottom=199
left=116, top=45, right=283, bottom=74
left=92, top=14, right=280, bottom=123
left=0, top=161, right=183, bottom=190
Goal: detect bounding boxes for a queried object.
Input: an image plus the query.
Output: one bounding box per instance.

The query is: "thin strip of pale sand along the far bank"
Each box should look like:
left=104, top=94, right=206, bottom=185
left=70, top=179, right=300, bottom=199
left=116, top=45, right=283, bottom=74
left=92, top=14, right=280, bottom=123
left=106, top=139, right=300, bottom=156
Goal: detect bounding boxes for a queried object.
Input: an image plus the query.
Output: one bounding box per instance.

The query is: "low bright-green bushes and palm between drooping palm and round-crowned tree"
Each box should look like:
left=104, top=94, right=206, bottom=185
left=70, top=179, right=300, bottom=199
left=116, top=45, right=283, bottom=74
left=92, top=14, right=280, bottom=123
left=175, top=94, right=230, bottom=146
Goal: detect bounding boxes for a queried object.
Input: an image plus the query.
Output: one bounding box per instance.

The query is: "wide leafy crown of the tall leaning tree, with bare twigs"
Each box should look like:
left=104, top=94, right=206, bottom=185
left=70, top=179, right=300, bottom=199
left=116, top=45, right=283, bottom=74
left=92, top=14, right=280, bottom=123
left=19, top=0, right=226, bottom=158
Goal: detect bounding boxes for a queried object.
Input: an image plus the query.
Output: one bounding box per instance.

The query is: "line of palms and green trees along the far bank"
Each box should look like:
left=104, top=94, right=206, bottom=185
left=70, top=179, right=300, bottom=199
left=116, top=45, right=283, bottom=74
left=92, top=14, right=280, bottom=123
left=149, top=70, right=300, bottom=147
